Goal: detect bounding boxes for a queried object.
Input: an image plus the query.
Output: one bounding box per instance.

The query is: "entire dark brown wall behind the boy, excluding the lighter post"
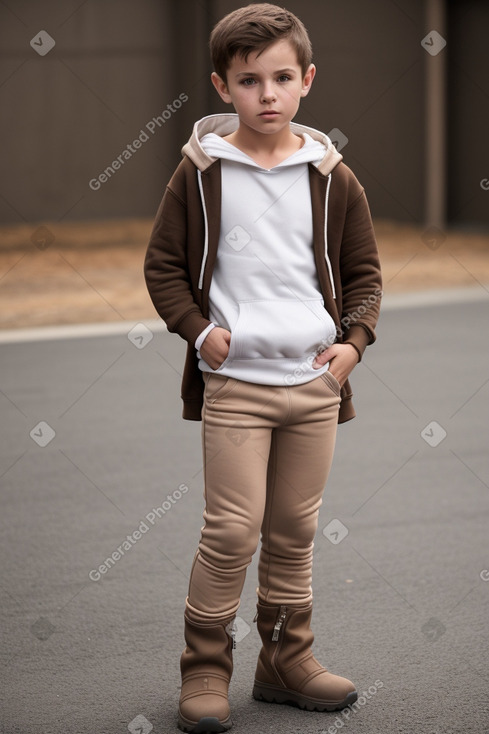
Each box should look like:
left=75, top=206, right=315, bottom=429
left=0, top=0, right=489, bottom=225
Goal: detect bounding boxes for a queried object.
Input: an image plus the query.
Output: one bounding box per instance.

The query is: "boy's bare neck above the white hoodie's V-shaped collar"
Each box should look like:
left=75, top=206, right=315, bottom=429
left=224, top=123, right=304, bottom=168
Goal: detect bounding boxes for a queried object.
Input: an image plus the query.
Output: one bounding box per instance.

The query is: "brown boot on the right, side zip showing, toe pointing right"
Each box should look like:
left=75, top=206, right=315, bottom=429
left=253, top=601, right=358, bottom=711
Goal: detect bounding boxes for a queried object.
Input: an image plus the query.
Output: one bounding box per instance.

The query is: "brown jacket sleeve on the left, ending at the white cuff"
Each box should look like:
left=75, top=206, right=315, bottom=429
left=144, top=169, right=210, bottom=345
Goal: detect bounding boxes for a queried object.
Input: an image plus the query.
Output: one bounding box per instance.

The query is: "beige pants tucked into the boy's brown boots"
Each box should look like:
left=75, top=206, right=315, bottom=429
left=187, top=372, right=340, bottom=618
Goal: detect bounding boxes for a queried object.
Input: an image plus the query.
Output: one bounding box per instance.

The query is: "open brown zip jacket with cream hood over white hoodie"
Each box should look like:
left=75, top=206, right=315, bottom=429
left=144, top=114, right=382, bottom=423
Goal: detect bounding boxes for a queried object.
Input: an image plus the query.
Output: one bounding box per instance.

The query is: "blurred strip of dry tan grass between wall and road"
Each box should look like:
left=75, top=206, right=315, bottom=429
left=0, top=219, right=489, bottom=329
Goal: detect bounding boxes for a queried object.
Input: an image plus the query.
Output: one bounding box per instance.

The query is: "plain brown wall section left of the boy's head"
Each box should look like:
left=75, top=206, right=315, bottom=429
left=0, top=0, right=184, bottom=222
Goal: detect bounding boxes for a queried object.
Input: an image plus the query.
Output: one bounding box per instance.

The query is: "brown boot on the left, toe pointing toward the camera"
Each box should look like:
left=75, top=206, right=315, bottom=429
left=178, top=601, right=235, bottom=734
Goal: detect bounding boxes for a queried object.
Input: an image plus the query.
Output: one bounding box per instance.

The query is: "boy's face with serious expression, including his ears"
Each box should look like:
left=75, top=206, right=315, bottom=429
left=211, top=40, right=316, bottom=135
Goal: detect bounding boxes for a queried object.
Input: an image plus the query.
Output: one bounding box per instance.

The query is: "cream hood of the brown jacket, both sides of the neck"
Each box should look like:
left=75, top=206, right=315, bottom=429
left=182, top=113, right=343, bottom=176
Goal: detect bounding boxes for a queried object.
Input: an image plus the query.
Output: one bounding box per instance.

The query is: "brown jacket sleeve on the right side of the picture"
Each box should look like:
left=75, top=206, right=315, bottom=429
left=340, top=189, right=382, bottom=360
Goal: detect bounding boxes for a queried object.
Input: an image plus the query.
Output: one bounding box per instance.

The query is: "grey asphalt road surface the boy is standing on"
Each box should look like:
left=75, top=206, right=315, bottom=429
left=0, top=299, right=489, bottom=734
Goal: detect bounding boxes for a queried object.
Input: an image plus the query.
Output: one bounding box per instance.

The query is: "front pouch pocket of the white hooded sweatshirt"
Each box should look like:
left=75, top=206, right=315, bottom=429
left=228, top=299, right=336, bottom=360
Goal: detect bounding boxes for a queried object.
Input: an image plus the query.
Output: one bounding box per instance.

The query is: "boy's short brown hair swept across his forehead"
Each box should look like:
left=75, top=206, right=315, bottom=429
left=209, top=3, right=312, bottom=81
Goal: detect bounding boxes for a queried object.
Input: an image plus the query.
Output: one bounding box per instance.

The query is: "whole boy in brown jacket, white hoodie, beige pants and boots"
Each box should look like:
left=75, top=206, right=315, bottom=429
left=145, top=3, right=382, bottom=734
